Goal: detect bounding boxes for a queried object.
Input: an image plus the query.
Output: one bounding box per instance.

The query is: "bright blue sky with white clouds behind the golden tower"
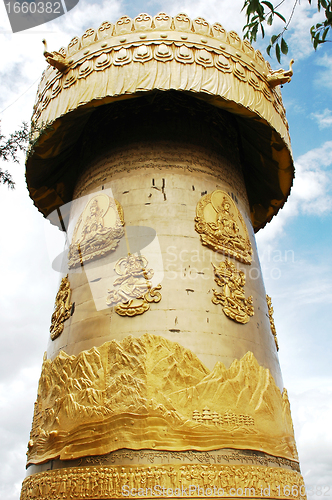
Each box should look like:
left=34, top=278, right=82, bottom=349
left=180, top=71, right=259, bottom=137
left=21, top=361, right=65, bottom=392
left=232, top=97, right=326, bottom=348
left=0, top=0, right=332, bottom=500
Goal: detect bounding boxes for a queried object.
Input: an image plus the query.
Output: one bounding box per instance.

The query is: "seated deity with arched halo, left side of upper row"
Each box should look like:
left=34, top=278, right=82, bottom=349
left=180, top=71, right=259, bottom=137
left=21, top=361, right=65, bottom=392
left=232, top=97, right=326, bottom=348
left=68, top=194, right=124, bottom=268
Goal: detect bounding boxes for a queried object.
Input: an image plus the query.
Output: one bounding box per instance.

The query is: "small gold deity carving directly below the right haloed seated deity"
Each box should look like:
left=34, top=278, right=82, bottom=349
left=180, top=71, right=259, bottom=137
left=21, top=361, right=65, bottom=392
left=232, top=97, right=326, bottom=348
left=211, top=259, right=254, bottom=324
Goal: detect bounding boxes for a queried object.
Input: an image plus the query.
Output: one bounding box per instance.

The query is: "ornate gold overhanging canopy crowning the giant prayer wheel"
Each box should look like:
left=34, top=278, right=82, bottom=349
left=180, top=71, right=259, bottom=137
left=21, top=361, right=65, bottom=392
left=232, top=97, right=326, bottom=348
left=26, top=13, right=294, bottom=230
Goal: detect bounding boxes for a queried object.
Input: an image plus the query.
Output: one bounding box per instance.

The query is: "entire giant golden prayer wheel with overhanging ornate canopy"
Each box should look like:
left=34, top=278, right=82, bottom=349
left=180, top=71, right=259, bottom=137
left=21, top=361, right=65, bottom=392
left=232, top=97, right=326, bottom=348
left=21, top=13, right=305, bottom=500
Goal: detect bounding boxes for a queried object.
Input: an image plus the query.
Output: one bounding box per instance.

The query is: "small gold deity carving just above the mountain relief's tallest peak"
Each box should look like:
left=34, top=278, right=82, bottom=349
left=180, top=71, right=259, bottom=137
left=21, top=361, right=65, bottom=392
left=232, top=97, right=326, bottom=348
left=106, top=254, right=161, bottom=316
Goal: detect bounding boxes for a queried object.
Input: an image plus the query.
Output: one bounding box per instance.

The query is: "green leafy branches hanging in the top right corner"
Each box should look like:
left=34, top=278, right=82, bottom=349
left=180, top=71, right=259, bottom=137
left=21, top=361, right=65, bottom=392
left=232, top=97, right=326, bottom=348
left=242, top=0, right=332, bottom=63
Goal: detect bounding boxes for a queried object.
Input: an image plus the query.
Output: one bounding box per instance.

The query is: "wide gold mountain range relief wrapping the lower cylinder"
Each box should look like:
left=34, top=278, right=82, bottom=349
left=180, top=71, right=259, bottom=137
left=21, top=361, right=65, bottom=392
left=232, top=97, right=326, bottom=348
left=28, top=334, right=297, bottom=464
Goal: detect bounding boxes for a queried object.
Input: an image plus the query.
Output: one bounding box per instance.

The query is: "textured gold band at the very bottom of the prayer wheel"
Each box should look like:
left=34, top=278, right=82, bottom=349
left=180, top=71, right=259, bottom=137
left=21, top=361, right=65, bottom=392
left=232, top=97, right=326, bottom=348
left=20, top=464, right=306, bottom=500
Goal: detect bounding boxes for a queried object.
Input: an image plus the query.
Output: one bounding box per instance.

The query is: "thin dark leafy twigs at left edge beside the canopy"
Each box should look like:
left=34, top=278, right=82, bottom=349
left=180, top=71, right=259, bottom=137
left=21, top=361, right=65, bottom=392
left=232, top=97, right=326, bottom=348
left=0, top=122, right=30, bottom=189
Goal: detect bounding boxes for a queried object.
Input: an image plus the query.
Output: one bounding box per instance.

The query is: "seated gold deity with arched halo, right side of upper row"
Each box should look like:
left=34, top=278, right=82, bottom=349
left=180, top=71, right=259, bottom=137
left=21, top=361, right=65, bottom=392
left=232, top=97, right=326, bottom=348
left=195, top=189, right=252, bottom=264
